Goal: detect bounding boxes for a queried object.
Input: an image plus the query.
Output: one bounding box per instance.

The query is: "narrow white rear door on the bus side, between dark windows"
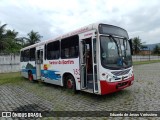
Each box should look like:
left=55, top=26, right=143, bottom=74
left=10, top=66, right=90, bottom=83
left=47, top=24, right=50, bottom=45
left=36, top=49, right=43, bottom=79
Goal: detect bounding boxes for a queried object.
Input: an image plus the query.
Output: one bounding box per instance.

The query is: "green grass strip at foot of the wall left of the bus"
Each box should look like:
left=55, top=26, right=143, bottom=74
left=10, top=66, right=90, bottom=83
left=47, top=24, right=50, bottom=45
left=0, top=72, right=23, bottom=85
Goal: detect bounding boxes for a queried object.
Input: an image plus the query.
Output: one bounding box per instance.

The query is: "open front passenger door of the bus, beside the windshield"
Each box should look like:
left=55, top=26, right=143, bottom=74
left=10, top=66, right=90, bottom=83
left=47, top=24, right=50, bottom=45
left=79, top=30, right=98, bottom=93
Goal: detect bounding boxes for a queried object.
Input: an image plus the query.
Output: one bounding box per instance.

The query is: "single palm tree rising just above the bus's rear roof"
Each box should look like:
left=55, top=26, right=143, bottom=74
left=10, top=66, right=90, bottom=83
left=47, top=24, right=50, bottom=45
left=24, top=30, right=42, bottom=46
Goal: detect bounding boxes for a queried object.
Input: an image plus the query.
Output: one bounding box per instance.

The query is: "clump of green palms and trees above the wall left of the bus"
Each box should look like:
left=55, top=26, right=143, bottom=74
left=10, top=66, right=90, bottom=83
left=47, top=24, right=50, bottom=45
left=0, top=21, right=42, bottom=53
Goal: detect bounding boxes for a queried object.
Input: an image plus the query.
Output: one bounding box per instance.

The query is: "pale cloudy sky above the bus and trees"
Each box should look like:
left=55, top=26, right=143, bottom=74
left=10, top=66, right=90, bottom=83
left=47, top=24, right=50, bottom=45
left=0, top=0, right=160, bottom=44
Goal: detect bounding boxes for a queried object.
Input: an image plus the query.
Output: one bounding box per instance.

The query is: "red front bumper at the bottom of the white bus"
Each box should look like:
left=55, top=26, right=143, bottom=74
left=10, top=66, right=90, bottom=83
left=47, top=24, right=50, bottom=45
left=100, top=76, right=134, bottom=95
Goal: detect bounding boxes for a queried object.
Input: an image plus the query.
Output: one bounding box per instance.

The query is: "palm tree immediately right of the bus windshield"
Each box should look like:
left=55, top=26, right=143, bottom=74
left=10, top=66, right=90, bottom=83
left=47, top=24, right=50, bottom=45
left=132, top=37, right=142, bottom=54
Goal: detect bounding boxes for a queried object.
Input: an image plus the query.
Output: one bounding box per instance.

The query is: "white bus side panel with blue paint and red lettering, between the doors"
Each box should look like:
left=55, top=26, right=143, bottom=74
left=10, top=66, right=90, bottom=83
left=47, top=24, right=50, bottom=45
left=41, top=58, right=80, bottom=90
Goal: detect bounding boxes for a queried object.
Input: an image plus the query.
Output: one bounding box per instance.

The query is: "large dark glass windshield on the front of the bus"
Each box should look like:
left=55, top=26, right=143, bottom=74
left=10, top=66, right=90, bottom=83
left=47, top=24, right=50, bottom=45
left=100, top=36, right=132, bottom=69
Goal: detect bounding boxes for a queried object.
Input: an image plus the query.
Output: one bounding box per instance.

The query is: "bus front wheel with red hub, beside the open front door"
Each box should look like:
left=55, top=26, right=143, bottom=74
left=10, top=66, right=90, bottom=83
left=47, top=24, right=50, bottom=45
left=65, top=75, right=76, bottom=93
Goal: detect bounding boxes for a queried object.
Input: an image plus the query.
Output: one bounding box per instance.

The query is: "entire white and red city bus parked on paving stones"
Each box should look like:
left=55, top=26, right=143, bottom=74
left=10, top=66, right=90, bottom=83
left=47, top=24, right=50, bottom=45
left=20, top=23, right=134, bottom=95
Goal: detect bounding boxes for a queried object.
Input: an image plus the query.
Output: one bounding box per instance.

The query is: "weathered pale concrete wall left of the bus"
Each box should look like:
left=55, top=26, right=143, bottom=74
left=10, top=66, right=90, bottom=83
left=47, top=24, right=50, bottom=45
left=0, top=54, right=20, bottom=73
